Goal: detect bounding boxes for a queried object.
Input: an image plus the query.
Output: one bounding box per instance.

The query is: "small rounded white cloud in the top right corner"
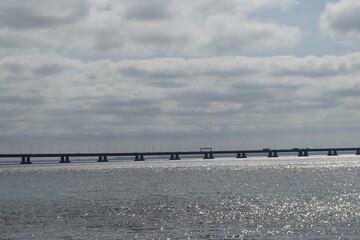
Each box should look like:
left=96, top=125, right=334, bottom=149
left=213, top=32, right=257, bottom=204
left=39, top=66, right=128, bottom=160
left=320, top=0, right=360, bottom=38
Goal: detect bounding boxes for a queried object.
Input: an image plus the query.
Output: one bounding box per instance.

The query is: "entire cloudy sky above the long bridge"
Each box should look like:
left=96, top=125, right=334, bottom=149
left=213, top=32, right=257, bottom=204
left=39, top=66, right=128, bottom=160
left=0, top=0, right=360, bottom=153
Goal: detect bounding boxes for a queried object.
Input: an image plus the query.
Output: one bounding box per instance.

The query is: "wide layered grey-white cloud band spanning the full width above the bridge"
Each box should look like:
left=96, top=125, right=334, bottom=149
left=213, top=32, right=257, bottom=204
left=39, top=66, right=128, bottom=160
left=0, top=53, right=360, bottom=142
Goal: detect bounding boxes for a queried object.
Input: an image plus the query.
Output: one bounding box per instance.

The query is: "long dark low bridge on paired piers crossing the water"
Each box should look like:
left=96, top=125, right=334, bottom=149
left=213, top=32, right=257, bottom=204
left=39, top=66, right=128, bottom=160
left=0, top=147, right=360, bottom=164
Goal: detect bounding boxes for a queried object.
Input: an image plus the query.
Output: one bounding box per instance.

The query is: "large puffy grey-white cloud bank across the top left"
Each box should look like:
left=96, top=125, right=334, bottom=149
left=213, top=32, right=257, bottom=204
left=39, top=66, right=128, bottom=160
left=0, top=0, right=302, bottom=58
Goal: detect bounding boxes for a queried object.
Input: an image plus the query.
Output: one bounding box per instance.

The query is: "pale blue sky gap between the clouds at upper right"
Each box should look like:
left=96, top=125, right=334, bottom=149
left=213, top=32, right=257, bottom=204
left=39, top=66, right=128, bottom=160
left=248, top=0, right=354, bottom=57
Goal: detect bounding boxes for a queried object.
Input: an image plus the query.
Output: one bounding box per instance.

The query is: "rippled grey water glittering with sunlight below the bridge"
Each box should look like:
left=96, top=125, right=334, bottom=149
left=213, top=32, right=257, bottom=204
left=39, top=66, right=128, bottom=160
left=0, top=155, right=360, bottom=239
